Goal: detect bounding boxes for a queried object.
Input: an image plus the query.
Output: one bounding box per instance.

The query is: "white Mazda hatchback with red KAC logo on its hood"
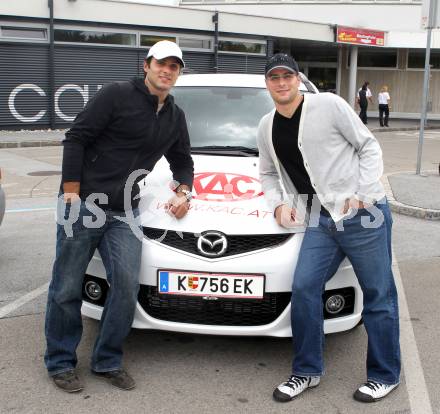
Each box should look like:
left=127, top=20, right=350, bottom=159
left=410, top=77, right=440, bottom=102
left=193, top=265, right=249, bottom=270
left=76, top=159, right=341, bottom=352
left=82, top=74, right=362, bottom=337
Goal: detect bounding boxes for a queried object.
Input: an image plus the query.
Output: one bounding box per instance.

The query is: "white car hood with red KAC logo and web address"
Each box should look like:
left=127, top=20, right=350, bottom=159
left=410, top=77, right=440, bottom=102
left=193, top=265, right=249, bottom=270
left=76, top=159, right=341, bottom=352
left=139, top=154, right=302, bottom=234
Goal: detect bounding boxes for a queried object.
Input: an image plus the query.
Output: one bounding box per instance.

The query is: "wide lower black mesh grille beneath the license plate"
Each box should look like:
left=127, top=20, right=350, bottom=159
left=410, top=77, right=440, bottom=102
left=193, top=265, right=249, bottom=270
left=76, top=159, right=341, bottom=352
left=138, top=285, right=291, bottom=326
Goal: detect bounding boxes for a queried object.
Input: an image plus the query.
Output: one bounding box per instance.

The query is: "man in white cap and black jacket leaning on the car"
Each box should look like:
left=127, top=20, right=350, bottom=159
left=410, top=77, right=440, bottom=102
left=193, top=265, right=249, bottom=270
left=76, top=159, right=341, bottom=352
left=45, top=41, right=193, bottom=392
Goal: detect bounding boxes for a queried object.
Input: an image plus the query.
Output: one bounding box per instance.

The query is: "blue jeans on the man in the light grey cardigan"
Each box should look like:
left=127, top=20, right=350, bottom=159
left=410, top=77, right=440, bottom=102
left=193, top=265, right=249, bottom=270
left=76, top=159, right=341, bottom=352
left=292, top=199, right=400, bottom=384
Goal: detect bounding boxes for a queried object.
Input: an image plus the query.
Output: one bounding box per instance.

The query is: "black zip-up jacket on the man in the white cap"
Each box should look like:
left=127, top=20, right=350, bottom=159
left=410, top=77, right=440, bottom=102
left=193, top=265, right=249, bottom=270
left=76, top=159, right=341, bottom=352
left=62, top=78, right=194, bottom=210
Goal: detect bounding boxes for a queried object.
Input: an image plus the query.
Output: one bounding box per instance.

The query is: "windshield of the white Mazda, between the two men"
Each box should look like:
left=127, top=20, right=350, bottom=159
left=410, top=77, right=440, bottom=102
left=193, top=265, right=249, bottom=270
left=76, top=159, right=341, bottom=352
left=173, top=86, right=273, bottom=148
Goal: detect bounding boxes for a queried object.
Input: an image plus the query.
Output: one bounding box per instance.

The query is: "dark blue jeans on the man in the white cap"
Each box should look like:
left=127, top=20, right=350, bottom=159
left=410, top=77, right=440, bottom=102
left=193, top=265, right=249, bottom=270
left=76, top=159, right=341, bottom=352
left=44, top=201, right=142, bottom=376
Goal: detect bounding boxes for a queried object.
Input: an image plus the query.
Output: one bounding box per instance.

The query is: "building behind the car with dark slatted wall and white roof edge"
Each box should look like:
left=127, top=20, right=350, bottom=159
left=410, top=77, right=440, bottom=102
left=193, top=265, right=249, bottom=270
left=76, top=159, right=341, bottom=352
left=0, top=0, right=440, bottom=129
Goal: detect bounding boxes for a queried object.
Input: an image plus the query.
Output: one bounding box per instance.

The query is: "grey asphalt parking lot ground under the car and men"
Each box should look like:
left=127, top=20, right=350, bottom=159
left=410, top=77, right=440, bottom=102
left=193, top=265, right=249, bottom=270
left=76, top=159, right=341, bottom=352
left=0, top=131, right=440, bottom=414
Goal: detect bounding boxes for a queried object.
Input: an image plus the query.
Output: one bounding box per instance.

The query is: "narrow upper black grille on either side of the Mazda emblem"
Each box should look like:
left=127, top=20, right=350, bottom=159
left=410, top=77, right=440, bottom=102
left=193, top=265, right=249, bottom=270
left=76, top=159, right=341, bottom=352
left=143, top=227, right=293, bottom=257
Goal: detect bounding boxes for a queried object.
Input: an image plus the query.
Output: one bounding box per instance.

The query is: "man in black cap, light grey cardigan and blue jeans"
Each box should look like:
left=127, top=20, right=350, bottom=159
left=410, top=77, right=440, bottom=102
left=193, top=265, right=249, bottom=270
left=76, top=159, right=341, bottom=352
left=258, top=54, right=400, bottom=402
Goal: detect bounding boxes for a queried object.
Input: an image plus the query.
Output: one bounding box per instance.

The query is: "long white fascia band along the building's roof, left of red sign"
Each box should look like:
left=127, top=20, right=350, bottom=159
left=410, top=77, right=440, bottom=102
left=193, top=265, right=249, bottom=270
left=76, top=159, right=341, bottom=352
left=0, top=0, right=334, bottom=42
